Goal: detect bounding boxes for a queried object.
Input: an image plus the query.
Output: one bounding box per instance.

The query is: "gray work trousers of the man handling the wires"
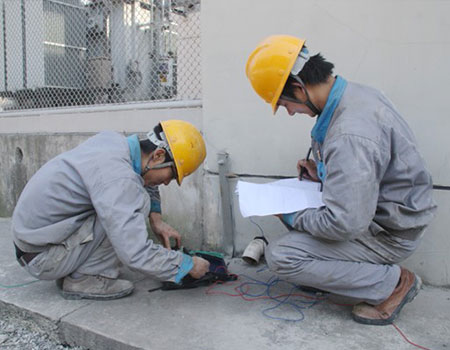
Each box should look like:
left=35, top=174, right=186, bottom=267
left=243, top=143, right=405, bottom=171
left=25, top=215, right=119, bottom=280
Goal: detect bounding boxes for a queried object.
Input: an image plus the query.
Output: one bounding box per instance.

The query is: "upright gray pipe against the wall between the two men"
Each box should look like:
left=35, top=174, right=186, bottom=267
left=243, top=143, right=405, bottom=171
left=217, top=153, right=234, bottom=257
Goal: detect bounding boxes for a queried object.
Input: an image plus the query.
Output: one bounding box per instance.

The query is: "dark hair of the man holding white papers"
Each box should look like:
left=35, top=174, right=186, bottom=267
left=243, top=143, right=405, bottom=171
left=282, top=53, right=334, bottom=98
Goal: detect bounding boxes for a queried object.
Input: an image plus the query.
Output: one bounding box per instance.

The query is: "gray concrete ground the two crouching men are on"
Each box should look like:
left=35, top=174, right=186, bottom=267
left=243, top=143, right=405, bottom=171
left=0, top=219, right=450, bottom=350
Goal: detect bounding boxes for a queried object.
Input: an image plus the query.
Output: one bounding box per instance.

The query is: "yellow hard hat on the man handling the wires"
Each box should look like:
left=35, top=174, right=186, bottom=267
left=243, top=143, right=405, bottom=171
left=161, top=120, right=206, bottom=185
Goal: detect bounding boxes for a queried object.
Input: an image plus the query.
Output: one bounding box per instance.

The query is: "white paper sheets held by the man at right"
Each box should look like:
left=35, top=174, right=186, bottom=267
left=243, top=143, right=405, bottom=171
left=236, top=178, right=323, bottom=217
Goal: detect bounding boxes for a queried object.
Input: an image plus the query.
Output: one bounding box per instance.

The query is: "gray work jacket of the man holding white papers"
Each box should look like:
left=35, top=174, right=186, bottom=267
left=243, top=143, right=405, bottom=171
left=291, top=83, right=436, bottom=241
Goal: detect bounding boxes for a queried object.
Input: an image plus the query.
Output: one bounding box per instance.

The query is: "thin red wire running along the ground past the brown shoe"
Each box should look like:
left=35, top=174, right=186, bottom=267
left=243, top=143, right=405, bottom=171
left=205, top=276, right=431, bottom=350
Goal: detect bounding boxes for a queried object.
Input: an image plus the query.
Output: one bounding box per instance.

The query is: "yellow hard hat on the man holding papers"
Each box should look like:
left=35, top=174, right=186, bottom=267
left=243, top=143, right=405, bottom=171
left=245, top=35, right=305, bottom=114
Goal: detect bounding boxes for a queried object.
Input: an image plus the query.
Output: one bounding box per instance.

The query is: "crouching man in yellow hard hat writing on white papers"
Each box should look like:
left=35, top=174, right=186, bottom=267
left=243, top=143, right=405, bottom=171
left=246, top=35, right=436, bottom=325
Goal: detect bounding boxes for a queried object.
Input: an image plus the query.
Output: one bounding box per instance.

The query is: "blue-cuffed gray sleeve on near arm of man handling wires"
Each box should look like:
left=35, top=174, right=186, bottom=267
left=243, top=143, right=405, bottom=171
left=90, top=178, right=193, bottom=282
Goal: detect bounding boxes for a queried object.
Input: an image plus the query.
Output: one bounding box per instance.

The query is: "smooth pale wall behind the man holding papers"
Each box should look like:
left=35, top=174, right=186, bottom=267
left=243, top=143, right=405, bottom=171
left=202, top=0, right=450, bottom=285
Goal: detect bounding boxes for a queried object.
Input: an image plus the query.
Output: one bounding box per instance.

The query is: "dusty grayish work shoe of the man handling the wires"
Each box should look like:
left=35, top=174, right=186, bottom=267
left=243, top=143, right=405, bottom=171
left=62, top=275, right=134, bottom=300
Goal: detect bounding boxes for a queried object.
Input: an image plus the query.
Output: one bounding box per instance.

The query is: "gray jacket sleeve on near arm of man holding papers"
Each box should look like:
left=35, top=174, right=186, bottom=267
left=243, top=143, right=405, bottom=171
left=282, top=135, right=383, bottom=241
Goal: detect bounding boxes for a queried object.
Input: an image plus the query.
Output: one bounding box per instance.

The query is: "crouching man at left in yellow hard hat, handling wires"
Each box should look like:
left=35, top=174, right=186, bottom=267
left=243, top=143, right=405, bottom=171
left=12, top=120, right=209, bottom=299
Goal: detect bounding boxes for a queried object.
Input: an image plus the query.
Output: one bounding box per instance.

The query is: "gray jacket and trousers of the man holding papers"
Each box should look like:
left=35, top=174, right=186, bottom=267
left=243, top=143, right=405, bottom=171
left=266, top=83, right=436, bottom=304
